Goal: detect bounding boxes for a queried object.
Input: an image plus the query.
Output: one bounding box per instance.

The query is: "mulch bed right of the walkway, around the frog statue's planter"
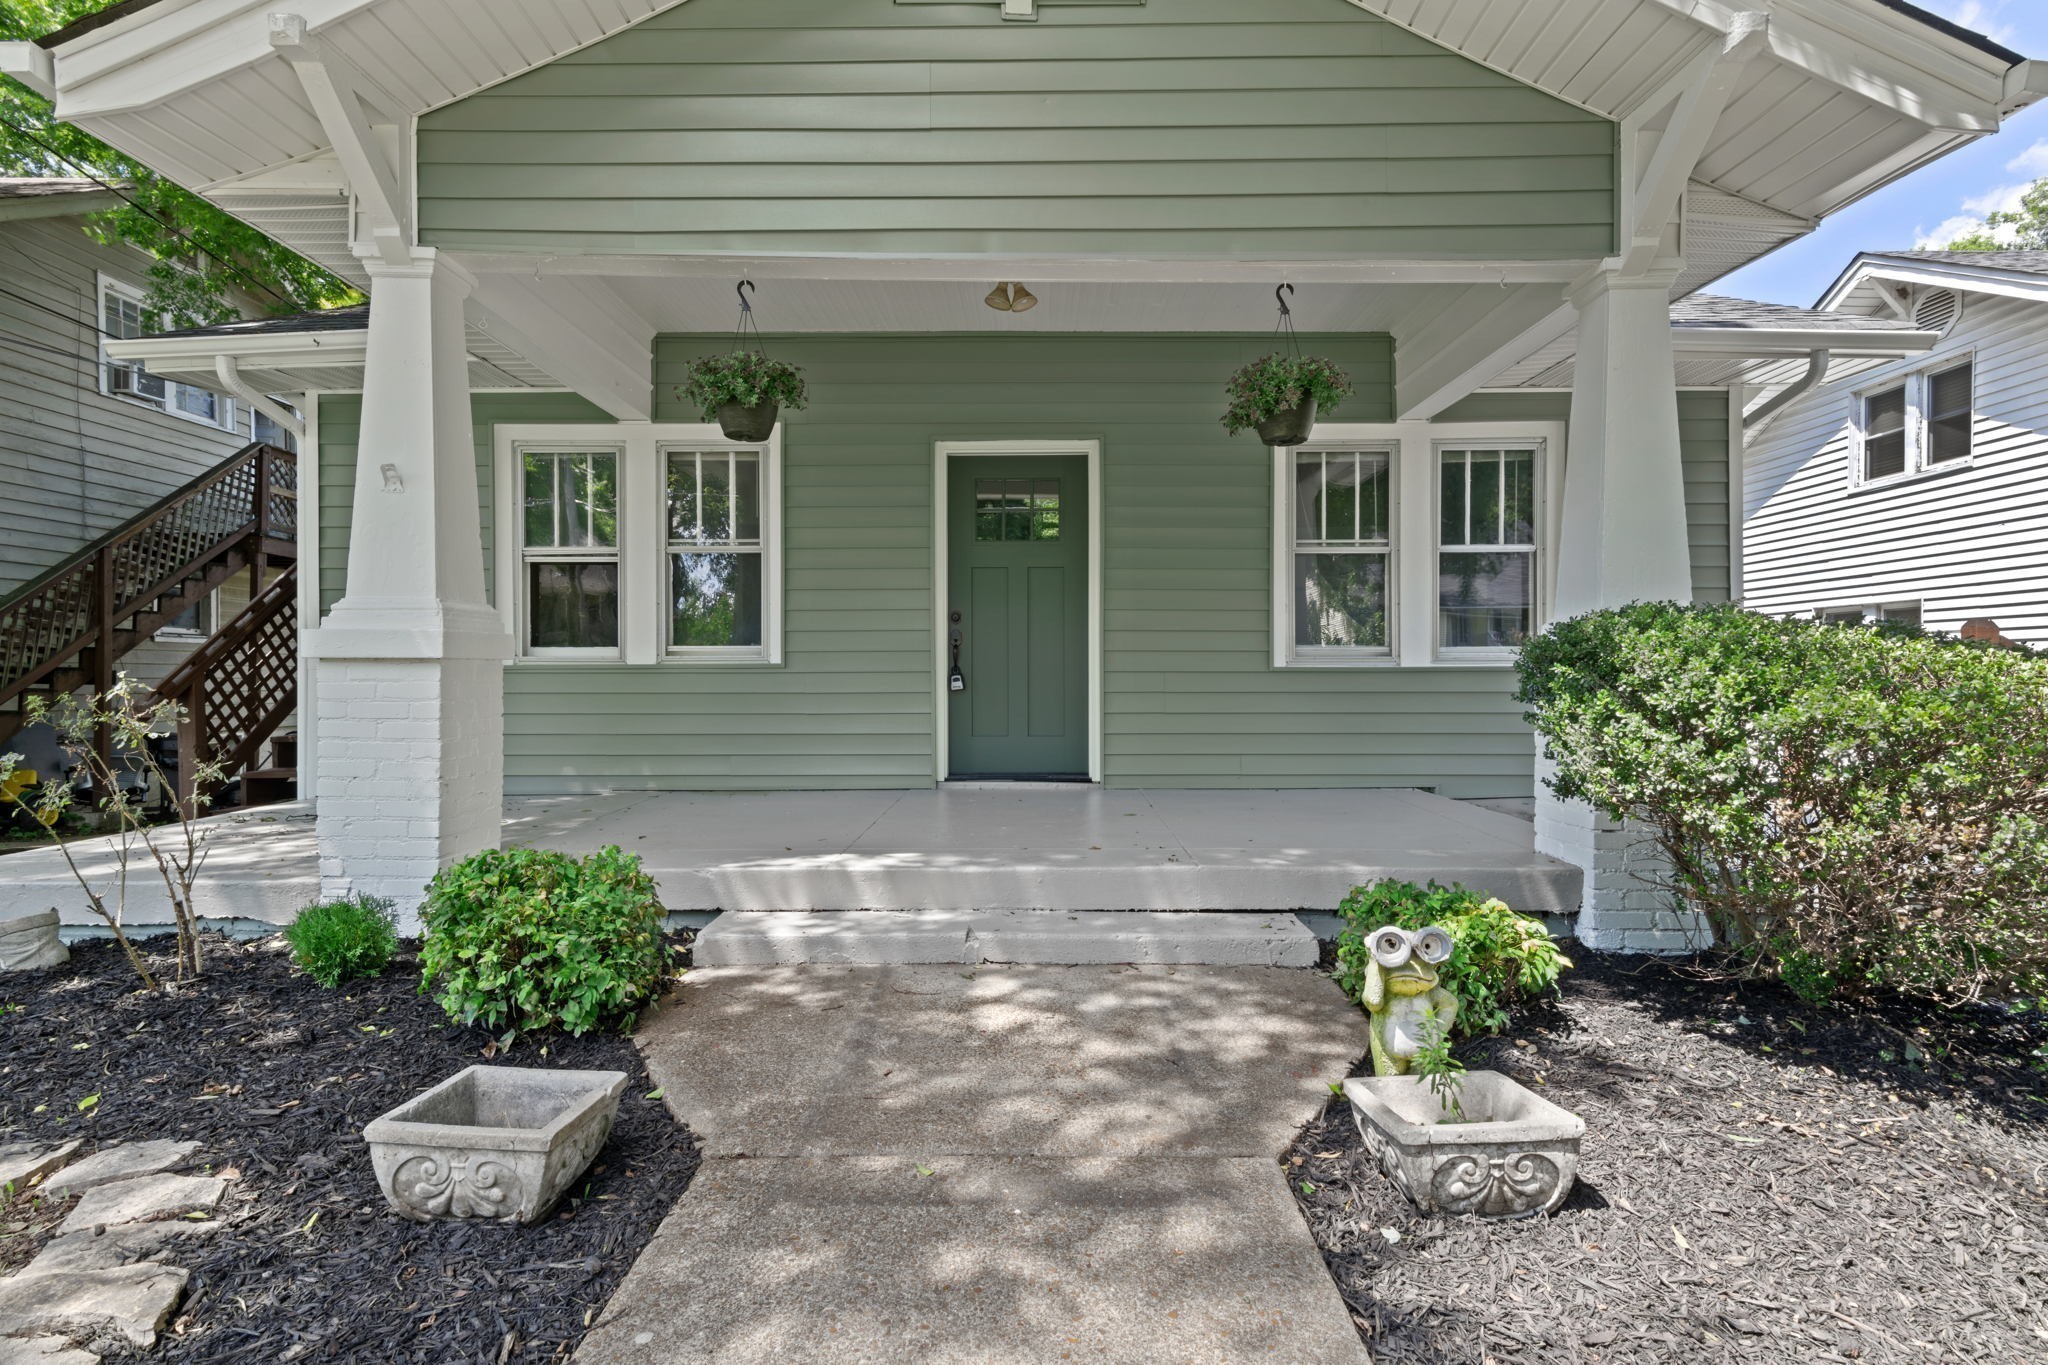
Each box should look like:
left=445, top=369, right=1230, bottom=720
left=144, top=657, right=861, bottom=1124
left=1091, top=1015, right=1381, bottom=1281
left=1286, top=950, right=2048, bottom=1365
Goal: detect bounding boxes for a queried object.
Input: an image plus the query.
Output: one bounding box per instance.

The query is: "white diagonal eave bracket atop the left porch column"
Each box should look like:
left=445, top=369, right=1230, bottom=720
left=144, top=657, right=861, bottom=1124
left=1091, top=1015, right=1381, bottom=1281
left=270, top=14, right=412, bottom=266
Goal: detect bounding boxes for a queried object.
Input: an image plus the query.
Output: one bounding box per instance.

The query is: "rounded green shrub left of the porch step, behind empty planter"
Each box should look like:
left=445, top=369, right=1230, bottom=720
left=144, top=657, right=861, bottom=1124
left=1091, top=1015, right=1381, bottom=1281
left=420, top=847, right=668, bottom=1033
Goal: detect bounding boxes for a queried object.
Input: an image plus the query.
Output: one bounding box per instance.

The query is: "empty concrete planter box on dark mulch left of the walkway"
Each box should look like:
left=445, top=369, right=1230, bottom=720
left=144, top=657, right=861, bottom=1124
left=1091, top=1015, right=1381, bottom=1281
left=362, top=1066, right=627, bottom=1224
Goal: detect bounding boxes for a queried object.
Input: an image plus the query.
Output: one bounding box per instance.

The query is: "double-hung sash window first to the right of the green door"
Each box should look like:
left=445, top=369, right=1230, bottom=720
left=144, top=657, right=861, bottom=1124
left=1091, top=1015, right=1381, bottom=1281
left=1290, top=450, right=1393, bottom=661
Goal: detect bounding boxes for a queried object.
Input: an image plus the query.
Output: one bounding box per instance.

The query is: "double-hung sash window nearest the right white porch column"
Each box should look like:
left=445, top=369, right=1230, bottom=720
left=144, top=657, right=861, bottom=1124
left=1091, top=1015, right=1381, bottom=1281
left=1436, top=448, right=1536, bottom=651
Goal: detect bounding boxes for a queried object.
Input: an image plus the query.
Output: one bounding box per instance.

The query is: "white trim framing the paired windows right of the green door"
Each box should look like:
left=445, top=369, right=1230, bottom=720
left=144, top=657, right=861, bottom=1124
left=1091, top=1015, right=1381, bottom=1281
left=1270, top=422, right=1565, bottom=669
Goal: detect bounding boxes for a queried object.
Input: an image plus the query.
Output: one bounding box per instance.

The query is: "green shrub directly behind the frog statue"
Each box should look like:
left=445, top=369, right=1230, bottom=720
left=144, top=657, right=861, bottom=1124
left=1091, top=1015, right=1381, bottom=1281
left=1337, top=882, right=1571, bottom=1033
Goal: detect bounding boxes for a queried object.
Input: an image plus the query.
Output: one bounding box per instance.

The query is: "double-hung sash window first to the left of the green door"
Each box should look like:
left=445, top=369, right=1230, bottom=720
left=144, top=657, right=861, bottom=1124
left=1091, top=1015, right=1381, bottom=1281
left=666, top=450, right=766, bottom=655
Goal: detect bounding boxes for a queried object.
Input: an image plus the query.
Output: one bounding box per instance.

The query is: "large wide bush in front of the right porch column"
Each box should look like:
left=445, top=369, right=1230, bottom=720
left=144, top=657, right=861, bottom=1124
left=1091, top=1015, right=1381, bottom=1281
left=1518, top=602, right=2048, bottom=999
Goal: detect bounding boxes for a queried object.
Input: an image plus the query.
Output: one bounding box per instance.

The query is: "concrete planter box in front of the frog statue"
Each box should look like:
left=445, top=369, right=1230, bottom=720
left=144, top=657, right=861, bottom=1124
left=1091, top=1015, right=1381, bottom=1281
left=1343, top=1070, right=1585, bottom=1218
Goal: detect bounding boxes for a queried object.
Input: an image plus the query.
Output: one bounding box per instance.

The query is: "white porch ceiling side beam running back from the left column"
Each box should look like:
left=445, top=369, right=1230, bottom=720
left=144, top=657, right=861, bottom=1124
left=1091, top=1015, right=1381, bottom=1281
left=467, top=266, right=651, bottom=422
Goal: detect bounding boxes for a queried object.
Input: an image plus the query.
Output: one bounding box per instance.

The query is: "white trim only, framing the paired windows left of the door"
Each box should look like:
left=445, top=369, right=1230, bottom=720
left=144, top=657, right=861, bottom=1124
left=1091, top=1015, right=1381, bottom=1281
left=492, top=422, right=782, bottom=669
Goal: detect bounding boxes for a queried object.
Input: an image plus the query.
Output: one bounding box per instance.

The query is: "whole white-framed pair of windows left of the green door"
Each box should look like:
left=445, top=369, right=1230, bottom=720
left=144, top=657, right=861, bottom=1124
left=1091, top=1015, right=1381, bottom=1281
left=494, top=422, right=782, bottom=665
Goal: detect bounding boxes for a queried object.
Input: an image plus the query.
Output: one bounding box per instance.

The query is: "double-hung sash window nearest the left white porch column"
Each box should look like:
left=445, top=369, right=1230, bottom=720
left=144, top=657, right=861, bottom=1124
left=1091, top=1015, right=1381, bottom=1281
left=520, top=450, right=618, bottom=657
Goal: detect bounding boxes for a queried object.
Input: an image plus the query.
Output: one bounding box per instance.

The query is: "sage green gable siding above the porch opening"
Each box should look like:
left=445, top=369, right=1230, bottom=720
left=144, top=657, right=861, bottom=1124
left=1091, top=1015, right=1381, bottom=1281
left=418, top=0, right=1616, bottom=258
